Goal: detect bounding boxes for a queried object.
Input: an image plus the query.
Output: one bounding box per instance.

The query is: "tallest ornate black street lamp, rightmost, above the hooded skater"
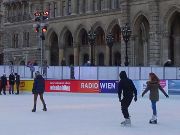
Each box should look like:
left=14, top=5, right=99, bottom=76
left=122, top=23, right=131, bottom=66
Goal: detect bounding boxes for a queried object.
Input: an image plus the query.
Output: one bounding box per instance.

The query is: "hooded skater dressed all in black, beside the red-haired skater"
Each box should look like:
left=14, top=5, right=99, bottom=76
left=118, top=71, right=137, bottom=125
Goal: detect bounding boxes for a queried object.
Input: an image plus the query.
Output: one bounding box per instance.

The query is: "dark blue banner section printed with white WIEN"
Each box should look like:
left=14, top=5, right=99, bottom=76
left=99, top=80, right=118, bottom=93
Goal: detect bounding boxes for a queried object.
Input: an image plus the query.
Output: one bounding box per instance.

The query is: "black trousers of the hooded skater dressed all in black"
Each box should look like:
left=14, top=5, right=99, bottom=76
left=121, top=97, right=133, bottom=119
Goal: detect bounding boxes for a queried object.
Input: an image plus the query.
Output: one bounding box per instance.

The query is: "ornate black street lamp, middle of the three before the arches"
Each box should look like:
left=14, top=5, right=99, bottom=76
left=106, top=33, right=114, bottom=66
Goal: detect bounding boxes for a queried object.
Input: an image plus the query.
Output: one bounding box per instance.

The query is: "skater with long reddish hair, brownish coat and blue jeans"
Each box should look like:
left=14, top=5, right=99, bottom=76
left=142, top=73, right=169, bottom=124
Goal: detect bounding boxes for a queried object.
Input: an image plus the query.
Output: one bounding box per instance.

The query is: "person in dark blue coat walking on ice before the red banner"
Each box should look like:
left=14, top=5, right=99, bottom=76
left=32, top=71, right=47, bottom=112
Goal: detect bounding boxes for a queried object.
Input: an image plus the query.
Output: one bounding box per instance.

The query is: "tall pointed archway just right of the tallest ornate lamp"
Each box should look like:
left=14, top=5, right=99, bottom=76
left=134, top=15, right=149, bottom=66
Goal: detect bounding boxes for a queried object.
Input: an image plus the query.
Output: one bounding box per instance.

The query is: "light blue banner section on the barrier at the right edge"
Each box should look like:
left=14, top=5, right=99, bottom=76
left=168, top=80, right=180, bottom=94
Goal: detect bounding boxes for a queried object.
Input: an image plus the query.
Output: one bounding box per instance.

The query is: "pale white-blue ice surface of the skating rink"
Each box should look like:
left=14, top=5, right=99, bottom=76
left=0, top=93, right=180, bottom=135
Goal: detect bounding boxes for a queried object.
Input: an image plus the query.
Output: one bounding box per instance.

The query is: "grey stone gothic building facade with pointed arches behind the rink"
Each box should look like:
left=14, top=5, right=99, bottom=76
left=0, top=0, right=180, bottom=66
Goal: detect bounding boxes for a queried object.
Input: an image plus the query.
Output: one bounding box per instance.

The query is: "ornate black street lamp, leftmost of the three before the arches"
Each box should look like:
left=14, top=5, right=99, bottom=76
left=88, top=29, right=96, bottom=66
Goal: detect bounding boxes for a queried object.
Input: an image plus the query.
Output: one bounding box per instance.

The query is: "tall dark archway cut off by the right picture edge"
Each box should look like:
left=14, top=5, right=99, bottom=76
left=169, top=12, right=180, bottom=66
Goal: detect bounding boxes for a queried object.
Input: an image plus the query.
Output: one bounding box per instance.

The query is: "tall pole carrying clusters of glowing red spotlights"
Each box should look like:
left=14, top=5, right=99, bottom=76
left=33, top=11, right=49, bottom=74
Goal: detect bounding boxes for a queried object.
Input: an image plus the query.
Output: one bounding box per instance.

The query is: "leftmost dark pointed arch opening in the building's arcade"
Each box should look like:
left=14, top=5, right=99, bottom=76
left=50, top=33, right=59, bottom=66
